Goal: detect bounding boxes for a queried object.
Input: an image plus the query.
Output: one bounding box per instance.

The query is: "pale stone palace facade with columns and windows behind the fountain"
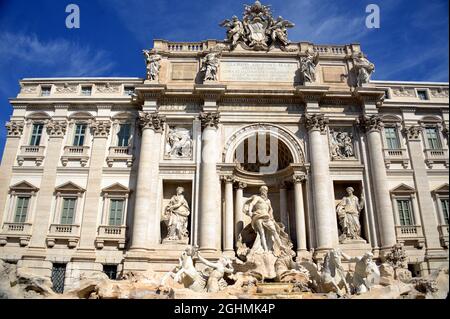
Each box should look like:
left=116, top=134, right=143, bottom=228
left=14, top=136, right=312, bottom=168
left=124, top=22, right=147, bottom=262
left=0, top=1, right=449, bottom=296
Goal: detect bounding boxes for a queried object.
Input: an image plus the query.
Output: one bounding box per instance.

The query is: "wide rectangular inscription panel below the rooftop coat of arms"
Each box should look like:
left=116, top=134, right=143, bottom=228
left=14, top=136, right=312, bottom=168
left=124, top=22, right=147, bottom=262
left=220, top=61, right=298, bottom=83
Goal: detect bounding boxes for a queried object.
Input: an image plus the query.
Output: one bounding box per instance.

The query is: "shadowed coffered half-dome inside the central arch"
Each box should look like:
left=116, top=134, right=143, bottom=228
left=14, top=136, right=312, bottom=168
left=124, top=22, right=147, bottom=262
left=233, top=132, right=294, bottom=173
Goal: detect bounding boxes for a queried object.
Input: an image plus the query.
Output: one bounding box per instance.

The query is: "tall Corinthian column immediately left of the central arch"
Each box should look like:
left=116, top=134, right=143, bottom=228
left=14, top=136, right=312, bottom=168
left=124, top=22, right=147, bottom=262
left=199, top=112, right=221, bottom=251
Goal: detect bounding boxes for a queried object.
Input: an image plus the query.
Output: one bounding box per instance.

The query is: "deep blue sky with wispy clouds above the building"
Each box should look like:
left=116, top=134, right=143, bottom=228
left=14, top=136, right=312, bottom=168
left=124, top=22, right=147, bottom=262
left=0, top=0, right=449, bottom=158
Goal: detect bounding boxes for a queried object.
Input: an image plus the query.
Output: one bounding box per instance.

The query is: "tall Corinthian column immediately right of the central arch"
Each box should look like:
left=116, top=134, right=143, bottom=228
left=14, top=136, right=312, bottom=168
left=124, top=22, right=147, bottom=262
left=306, top=114, right=338, bottom=250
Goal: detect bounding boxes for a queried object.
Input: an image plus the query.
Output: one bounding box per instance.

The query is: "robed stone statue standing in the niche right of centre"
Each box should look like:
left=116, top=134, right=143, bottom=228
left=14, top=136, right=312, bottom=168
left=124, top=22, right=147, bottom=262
left=336, top=187, right=364, bottom=243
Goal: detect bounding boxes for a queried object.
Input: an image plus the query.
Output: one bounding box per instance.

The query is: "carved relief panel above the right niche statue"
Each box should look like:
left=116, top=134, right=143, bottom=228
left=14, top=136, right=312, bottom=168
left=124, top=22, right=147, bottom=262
left=329, top=128, right=356, bottom=161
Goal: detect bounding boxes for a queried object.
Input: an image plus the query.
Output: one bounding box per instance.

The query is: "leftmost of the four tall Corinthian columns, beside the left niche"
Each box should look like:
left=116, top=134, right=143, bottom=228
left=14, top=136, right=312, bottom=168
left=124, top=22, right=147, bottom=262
left=131, top=112, right=165, bottom=249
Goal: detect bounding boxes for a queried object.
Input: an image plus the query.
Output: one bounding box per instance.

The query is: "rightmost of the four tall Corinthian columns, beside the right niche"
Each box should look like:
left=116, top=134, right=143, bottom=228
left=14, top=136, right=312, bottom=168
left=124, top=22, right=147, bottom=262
left=361, top=115, right=396, bottom=249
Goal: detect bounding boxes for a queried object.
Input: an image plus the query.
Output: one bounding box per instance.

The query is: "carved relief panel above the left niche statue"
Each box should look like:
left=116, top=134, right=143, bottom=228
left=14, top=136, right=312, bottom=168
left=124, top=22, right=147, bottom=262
left=166, top=127, right=192, bottom=158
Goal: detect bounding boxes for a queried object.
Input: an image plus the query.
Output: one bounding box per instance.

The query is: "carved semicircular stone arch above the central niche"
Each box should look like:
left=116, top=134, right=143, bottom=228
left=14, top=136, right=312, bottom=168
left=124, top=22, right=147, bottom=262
left=222, top=123, right=305, bottom=164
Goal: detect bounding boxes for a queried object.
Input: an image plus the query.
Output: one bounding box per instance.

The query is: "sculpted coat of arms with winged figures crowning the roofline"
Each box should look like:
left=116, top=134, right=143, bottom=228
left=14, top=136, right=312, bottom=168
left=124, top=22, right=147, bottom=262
left=220, top=1, right=294, bottom=50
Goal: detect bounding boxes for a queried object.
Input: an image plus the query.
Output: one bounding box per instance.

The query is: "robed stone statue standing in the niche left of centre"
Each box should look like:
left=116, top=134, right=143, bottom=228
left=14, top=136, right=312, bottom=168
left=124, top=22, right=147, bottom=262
left=163, top=187, right=190, bottom=243
